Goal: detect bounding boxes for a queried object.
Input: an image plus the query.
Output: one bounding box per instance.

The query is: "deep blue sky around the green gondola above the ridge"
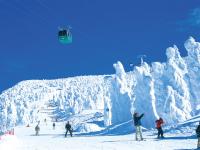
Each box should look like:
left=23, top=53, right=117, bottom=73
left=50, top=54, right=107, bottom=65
left=0, top=0, right=200, bottom=91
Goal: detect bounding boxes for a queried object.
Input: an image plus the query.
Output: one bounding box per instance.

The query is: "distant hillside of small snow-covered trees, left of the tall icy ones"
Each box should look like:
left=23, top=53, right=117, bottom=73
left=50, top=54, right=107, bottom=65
left=0, top=76, right=105, bottom=131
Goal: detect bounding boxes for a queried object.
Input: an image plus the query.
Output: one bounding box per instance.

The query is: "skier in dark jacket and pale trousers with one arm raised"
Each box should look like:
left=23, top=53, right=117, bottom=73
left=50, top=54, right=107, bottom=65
left=133, top=112, right=144, bottom=141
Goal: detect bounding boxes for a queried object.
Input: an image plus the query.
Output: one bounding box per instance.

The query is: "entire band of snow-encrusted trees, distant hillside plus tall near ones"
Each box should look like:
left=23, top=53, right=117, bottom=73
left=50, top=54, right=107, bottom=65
left=0, top=37, right=200, bottom=132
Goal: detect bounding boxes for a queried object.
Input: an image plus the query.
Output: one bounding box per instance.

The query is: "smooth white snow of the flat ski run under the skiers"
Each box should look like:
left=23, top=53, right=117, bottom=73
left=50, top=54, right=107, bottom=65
left=0, top=120, right=197, bottom=150
